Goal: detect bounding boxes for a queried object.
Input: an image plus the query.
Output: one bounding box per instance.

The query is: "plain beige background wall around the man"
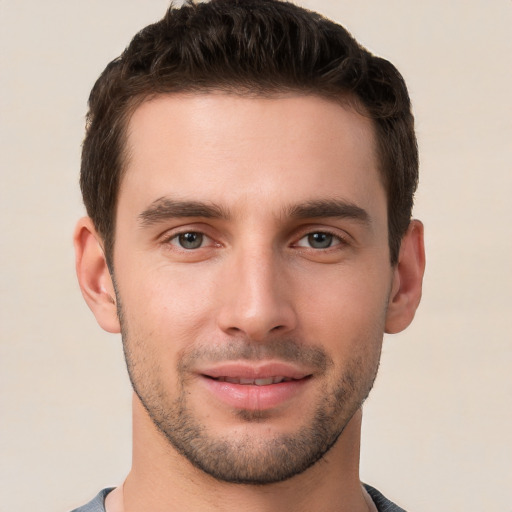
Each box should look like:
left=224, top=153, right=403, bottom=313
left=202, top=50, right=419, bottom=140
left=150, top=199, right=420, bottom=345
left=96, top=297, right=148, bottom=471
left=0, top=0, right=512, bottom=512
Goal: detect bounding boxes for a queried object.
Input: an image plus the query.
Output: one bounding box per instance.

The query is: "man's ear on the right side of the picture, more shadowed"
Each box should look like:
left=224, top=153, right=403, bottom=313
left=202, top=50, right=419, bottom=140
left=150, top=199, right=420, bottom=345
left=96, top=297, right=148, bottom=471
left=386, top=220, right=425, bottom=334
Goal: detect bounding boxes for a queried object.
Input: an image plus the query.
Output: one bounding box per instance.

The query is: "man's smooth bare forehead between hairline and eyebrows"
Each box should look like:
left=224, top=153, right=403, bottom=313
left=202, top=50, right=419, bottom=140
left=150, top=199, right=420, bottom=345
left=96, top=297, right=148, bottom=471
left=120, top=93, right=382, bottom=216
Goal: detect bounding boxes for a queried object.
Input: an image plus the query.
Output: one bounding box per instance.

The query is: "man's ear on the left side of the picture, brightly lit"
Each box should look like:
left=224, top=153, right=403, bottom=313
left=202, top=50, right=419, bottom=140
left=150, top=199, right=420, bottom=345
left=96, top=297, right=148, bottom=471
left=73, top=217, right=121, bottom=333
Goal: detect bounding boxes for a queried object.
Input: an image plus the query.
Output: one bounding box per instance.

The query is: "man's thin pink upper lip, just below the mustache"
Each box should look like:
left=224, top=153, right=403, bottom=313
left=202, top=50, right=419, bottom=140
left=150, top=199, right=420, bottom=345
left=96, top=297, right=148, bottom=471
left=197, top=361, right=311, bottom=380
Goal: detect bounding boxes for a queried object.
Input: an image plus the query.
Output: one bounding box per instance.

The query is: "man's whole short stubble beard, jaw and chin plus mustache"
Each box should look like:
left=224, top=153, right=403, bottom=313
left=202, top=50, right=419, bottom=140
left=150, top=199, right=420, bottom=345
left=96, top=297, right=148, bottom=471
left=118, top=301, right=380, bottom=485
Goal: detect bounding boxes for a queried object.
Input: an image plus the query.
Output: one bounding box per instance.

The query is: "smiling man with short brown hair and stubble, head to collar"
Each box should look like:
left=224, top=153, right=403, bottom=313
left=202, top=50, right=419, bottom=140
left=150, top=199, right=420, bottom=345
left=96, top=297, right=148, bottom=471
left=71, top=0, right=424, bottom=512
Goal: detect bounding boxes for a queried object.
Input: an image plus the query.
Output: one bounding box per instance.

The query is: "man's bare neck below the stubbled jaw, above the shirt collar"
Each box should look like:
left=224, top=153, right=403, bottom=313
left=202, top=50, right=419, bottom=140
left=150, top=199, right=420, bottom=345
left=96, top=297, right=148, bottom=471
left=118, top=398, right=368, bottom=512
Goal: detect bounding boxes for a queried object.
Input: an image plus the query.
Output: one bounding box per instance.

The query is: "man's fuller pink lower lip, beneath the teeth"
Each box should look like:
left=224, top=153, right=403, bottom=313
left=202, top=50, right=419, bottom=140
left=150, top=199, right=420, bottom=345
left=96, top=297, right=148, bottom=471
left=202, top=376, right=310, bottom=411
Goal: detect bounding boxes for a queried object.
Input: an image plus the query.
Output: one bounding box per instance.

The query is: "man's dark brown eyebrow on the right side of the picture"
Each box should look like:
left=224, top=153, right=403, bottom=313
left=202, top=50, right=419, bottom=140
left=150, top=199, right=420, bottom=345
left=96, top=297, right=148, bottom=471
left=287, top=199, right=370, bottom=224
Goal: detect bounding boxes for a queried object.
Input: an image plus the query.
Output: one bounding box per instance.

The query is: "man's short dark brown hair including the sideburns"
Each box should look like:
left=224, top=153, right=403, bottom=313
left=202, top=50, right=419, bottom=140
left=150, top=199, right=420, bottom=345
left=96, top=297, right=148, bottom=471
left=80, top=0, right=418, bottom=269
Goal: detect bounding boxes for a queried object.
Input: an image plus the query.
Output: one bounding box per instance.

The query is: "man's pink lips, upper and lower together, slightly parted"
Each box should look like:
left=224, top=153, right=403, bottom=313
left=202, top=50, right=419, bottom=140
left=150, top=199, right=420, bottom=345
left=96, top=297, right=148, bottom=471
left=198, top=362, right=312, bottom=411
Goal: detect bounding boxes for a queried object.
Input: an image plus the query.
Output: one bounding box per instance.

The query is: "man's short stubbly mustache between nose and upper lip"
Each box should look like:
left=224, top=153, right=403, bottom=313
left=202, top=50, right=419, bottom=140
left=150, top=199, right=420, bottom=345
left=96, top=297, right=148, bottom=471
left=179, top=339, right=334, bottom=372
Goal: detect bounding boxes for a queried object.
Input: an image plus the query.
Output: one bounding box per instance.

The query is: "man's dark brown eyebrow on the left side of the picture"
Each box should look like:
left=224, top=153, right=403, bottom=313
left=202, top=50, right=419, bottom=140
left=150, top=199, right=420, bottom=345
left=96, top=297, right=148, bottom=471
left=139, top=197, right=229, bottom=227
